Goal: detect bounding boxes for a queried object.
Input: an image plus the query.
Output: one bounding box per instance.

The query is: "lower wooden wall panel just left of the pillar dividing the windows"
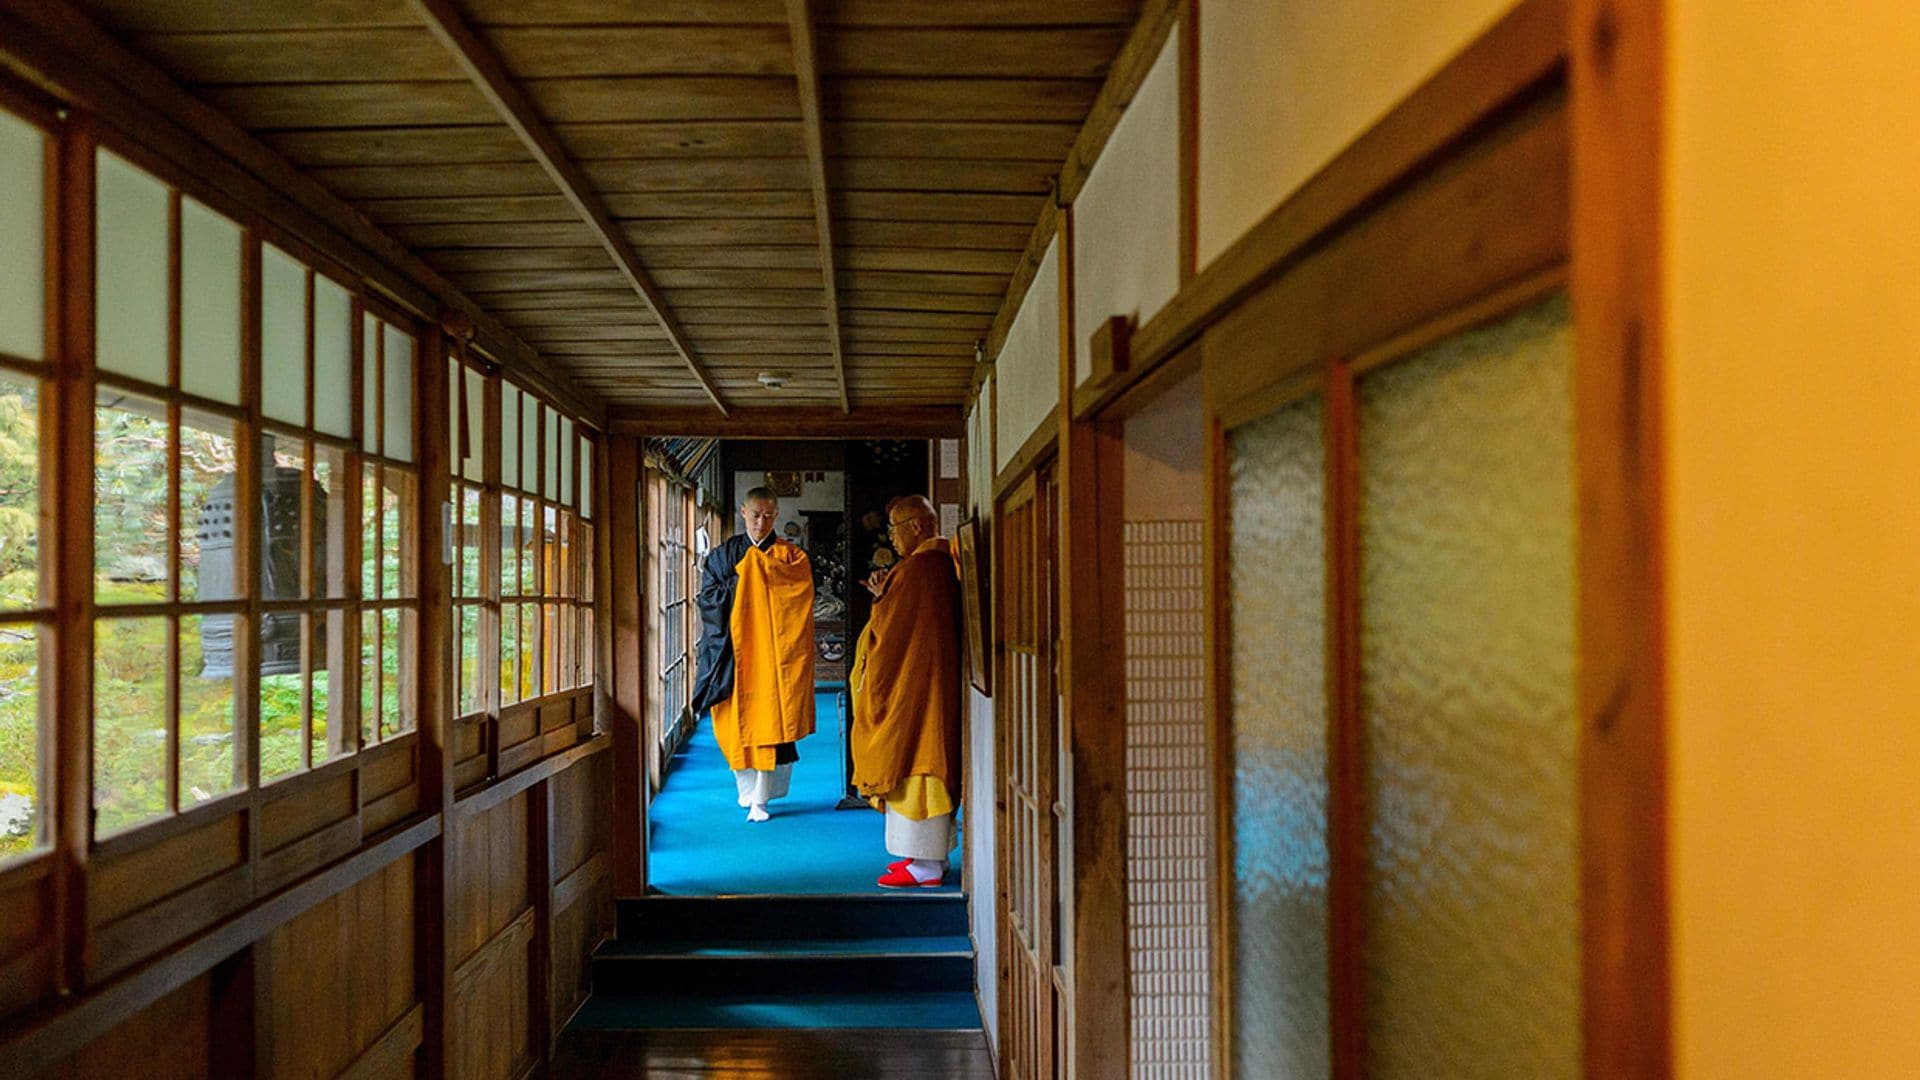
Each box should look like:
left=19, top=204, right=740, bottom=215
left=255, top=853, right=417, bottom=1076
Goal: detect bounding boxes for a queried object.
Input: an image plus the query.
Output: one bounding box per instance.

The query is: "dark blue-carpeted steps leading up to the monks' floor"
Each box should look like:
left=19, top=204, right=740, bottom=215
left=570, top=894, right=981, bottom=1030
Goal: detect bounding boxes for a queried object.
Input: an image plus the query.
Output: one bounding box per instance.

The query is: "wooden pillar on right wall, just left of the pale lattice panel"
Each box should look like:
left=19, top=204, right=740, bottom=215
left=1058, top=208, right=1129, bottom=1078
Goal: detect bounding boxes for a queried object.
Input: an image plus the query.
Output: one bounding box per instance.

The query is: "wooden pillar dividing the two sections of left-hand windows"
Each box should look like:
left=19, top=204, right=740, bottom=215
left=413, top=315, right=458, bottom=1080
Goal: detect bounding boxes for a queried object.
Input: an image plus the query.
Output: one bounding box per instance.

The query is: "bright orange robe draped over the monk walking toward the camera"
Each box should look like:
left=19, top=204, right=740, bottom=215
left=712, top=544, right=814, bottom=773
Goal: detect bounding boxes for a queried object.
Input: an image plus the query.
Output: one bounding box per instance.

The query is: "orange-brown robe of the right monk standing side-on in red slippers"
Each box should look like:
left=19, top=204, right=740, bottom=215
left=849, top=536, right=962, bottom=821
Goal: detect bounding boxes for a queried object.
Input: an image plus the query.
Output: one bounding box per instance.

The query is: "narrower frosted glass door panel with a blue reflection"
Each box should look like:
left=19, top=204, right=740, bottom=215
left=1227, top=390, right=1329, bottom=1078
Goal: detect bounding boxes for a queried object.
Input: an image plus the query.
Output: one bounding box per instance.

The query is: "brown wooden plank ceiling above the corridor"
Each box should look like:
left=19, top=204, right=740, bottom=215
left=88, top=0, right=1139, bottom=409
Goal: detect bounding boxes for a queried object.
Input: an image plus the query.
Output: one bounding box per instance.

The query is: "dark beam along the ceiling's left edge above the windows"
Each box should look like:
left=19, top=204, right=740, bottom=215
left=0, top=0, right=605, bottom=423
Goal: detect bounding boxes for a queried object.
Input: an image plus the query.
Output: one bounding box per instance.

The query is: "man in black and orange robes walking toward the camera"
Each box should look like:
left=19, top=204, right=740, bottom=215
left=693, top=488, right=814, bottom=822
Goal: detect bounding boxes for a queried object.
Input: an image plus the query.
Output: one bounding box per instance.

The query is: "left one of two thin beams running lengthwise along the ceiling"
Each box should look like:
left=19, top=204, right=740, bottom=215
left=413, top=0, right=728, bottom=415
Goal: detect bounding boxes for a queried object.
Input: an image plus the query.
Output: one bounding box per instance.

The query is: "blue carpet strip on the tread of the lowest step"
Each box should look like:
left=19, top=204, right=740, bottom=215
left=566, top=992, right=979, bottom=1032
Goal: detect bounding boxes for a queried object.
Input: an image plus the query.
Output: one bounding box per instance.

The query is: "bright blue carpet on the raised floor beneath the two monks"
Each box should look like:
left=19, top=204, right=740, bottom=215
left=647, top=694, right=977, bottom=891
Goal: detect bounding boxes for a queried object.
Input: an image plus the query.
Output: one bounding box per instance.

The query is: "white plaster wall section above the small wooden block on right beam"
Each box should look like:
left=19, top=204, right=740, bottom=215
left=1073, top=33, right=1181, bottom=386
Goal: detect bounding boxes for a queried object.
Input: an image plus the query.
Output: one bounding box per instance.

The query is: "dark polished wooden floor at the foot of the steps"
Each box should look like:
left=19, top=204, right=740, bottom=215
left=547, top=1030, right=993, bottom=1080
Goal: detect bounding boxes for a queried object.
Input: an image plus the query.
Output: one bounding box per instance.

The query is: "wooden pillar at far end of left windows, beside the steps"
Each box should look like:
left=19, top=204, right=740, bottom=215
left=603, top=434, right=647, bottom=896
